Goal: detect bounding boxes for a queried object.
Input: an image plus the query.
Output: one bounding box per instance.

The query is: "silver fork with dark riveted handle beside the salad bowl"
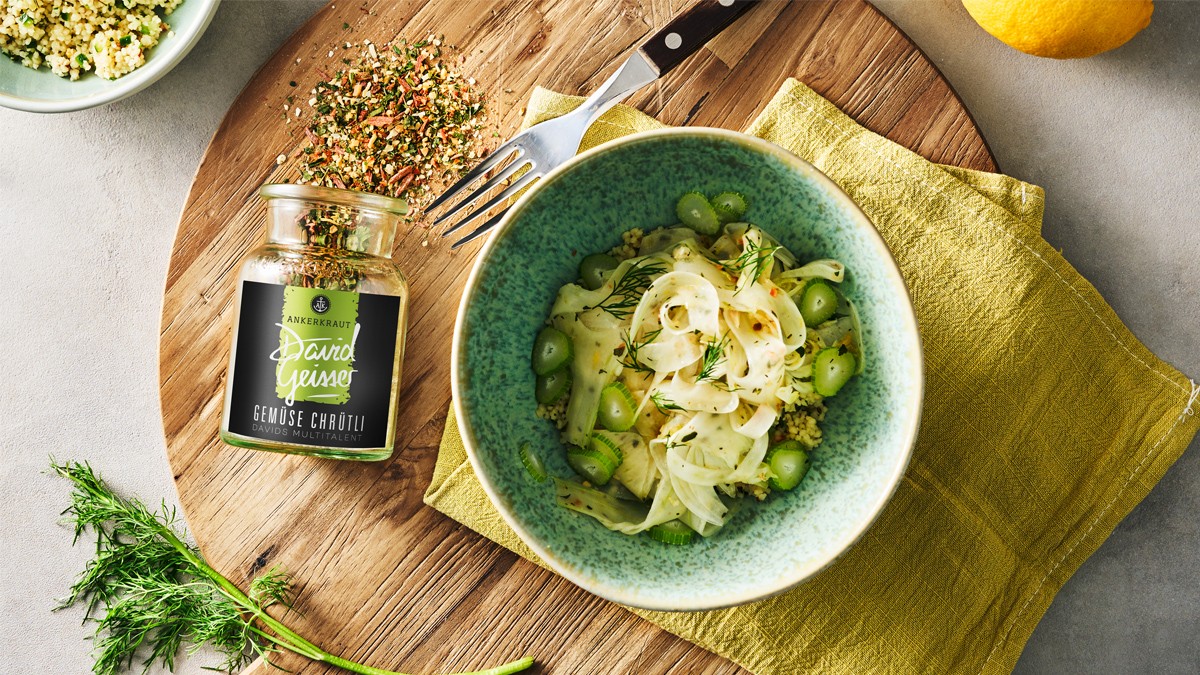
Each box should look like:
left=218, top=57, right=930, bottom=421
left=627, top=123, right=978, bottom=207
left=426, top=0, right=755, bottom=249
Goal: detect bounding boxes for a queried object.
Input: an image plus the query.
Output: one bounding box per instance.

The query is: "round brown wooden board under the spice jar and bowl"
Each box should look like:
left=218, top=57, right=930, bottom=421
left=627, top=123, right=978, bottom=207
left=160, top=0, right=996, bottom=675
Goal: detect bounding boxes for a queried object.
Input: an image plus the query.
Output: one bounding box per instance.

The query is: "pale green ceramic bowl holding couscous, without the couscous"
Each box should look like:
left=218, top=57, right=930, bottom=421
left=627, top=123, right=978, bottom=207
left=0, top=0, right=220, bottom=113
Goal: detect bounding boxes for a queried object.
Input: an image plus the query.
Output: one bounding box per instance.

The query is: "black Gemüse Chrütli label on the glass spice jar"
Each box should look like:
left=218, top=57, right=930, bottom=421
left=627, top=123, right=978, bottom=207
left=228, top=281, right=400, bottom=448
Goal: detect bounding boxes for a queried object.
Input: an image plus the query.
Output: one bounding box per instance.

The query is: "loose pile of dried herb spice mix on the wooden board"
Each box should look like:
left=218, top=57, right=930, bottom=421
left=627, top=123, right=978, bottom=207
left=291, top=36, right=487, bottom=207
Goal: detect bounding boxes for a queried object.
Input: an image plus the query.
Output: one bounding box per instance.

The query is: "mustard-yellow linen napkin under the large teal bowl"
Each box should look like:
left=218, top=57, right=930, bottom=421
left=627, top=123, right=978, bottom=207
left=425, top=80, right=1200, bottom=675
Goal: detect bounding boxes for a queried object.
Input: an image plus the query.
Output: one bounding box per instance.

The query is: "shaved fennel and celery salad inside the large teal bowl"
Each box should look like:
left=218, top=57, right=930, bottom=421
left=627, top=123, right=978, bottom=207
left=532, top=187, right=865, bottom=545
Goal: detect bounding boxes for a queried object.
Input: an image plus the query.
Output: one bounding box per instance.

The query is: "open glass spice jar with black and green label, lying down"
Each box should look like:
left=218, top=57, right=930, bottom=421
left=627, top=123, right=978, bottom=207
left=221, top=184, right=408, bottom=460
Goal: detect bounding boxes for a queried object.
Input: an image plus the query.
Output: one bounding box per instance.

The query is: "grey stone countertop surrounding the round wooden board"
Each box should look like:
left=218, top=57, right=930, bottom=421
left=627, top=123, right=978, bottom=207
left=0, top=0, right=1200, bottom=675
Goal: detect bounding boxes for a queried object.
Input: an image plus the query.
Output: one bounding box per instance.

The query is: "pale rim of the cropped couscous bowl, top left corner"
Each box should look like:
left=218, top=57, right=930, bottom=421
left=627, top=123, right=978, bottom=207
left=0, top=0, right=221, bottom=113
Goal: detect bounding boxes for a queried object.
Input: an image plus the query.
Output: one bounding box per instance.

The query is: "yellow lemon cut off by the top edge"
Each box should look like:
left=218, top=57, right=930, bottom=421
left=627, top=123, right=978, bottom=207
left=962, top=0, right=1154, bottom=59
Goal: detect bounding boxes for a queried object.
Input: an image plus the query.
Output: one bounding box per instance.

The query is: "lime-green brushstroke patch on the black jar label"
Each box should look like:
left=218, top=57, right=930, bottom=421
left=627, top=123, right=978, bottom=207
left=271, top=286, right=359, bottom=405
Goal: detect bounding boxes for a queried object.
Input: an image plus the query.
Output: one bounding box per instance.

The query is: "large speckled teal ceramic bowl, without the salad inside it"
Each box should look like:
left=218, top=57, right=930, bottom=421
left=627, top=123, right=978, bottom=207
left=452, top=129, right=923, bottom=610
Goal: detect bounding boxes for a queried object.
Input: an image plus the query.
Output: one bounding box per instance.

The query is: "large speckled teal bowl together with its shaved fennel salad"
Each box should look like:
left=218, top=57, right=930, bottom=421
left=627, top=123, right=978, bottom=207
left=451, top=129, right=923, bottom=610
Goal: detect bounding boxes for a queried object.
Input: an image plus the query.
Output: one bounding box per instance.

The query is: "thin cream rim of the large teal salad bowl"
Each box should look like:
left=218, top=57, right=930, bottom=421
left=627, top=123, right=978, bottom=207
left=450, top=126, right=925, bottom=611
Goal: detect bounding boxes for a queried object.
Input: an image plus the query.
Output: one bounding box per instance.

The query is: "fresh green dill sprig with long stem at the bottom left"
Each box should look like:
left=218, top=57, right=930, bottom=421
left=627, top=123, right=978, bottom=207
left=50, top=459, right=533, bottom=675
